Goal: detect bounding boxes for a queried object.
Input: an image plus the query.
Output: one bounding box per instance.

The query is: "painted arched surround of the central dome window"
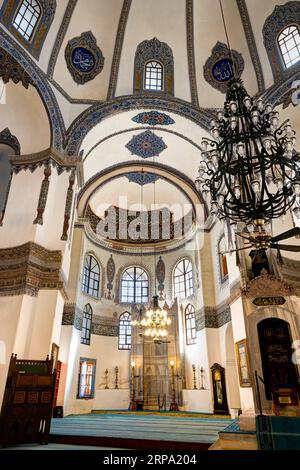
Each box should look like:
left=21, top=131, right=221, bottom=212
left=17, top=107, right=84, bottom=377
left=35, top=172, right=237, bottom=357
left=133, top=38, right=174, bottom=96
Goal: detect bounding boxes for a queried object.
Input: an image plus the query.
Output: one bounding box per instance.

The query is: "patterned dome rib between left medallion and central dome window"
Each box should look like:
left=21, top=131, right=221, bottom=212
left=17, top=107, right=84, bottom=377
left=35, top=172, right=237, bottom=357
left=107, top=0, right=132, bottom=101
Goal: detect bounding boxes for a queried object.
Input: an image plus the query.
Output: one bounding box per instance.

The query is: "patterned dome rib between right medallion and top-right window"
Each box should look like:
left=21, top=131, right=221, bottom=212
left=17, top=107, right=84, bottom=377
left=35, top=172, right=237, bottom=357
left=236, top=0, right=266, bottom=93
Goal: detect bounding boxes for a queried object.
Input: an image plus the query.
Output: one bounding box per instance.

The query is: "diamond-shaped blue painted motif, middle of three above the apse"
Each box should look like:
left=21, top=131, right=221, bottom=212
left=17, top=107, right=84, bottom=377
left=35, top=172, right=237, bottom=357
left=125, top=131, right=167, bottom=158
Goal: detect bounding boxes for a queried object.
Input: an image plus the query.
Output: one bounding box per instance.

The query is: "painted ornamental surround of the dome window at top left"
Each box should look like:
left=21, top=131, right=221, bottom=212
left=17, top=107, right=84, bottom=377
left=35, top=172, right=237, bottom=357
left=0, top=0, right=56, bottom=59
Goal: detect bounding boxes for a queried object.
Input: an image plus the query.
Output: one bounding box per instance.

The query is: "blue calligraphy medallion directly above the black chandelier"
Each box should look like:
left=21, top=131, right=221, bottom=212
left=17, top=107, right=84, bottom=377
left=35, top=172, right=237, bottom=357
left=203, top=42, right=245, bottom=93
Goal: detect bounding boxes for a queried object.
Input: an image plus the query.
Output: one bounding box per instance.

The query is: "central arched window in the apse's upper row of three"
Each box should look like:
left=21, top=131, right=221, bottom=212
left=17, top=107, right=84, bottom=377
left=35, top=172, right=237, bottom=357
left=121, top=266, right=149, bottom=304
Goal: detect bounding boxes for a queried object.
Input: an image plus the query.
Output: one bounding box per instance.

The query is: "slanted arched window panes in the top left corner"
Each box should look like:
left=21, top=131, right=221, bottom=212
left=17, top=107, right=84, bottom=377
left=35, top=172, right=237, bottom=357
left=13, top=0, right=41, bottom=41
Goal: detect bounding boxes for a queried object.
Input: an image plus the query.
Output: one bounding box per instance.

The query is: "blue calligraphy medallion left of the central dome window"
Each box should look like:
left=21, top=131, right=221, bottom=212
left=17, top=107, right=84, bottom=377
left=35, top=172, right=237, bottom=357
left=65, top=31, right=104, bottom=85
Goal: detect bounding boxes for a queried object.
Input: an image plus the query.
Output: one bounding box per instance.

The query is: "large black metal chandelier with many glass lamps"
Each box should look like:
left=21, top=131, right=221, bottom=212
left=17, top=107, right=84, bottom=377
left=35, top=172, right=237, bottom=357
left=195, top=79, right=300, bottom=230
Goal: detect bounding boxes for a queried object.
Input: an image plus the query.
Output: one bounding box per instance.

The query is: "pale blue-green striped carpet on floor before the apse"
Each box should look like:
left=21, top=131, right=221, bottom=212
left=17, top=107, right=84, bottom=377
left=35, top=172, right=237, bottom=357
left=50, top=413, right=233, bottom=447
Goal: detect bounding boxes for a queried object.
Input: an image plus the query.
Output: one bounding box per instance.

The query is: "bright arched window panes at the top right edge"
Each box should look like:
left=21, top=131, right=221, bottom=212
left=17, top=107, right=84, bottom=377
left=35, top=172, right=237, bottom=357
left=278, top=25, right=300, bottom=68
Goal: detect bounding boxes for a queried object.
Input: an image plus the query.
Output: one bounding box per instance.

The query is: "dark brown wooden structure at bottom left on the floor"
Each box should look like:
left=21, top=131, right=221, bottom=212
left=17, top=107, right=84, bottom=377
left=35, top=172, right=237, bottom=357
left=0, top=354, right=56, bottom=446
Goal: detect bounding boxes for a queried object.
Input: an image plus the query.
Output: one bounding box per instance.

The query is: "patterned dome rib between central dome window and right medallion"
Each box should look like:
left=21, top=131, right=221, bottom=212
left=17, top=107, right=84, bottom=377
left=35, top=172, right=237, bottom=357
left=186, top=0, right=199, bottom=107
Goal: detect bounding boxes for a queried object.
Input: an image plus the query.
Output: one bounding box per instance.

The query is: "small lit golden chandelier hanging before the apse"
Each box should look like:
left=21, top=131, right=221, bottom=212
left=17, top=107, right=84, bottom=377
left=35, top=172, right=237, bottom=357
left=132, top=295, right=171, bottom=341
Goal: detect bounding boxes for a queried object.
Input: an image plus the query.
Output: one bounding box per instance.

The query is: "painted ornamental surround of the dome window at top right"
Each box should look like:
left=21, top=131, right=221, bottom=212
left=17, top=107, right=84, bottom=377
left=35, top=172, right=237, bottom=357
left=262, top=1, right=300, bottom=82
